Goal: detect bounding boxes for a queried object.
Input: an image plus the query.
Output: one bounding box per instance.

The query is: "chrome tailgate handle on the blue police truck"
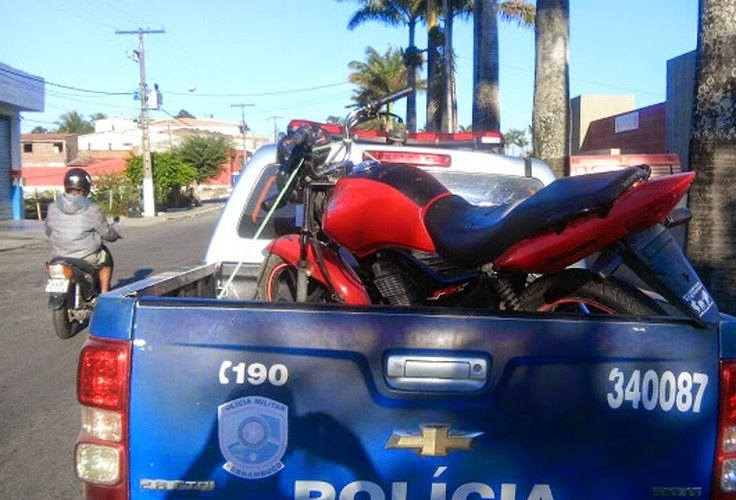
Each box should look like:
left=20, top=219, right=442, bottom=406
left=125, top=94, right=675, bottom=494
left=385, top=354, right=488, bottom=392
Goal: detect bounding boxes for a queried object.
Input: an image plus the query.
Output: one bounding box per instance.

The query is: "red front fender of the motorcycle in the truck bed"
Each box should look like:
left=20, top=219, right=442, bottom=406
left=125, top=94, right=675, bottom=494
left=266, top=234, right=371, bottom=305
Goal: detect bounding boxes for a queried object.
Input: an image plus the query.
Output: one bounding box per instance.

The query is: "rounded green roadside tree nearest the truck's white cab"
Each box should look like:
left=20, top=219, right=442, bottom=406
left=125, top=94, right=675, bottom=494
left=174, top=133, right=233, bottom=184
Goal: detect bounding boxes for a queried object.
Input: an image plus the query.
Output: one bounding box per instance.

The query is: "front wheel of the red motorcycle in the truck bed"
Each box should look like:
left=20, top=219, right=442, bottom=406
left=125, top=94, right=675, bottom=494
left=256, top=254, right=334, bottom=303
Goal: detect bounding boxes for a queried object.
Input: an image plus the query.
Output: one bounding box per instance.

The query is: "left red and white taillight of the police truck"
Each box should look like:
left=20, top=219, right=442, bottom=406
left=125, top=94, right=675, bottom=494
left=74, top=337, right=131, bottom=500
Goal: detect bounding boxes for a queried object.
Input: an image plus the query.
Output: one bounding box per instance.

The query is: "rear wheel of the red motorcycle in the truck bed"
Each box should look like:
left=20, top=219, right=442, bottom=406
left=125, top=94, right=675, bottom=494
left=519, top=269, right=665, bottom=316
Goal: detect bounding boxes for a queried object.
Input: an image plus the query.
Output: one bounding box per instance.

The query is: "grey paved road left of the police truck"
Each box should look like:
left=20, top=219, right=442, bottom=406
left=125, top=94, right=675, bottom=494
left=0, top=204, right=222, bottom=500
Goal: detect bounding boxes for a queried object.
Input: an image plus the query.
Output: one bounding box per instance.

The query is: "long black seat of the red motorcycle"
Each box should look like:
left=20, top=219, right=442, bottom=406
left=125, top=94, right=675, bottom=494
left=424, top=166, right=649, bottom=267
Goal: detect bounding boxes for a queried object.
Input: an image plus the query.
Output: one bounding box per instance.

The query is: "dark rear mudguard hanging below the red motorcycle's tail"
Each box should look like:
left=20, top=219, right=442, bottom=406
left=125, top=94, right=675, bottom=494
left=591, top=224, right=720, bottom=324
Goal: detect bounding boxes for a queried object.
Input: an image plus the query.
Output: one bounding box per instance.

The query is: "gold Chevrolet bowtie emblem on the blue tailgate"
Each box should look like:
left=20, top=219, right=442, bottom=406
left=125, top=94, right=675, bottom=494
left=386, top=424, right=483, bottom=457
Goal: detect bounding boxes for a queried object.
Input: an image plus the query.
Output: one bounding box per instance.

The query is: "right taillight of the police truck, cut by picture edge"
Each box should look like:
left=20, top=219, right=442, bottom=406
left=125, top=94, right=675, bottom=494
left=711, top=361, right=736, bottom=500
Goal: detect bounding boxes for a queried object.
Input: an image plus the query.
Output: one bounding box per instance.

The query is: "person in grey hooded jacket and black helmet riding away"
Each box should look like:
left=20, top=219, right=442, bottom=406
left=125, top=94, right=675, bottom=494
left=46, top=168, right=120, bottom=293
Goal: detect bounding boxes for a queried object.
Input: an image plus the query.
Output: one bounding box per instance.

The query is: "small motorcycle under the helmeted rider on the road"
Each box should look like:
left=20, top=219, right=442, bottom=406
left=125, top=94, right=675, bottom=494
left=46, top=217, right=120, bottom=339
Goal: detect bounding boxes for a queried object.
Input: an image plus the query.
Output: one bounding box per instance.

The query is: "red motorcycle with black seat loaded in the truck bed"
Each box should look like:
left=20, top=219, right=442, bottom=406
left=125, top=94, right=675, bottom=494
left=257, top=89, right=719, bottom=323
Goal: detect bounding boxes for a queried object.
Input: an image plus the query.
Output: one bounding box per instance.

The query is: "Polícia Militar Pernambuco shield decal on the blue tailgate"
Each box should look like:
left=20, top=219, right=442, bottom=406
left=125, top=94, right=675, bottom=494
left=217, top=396, right=289, bottom=479
